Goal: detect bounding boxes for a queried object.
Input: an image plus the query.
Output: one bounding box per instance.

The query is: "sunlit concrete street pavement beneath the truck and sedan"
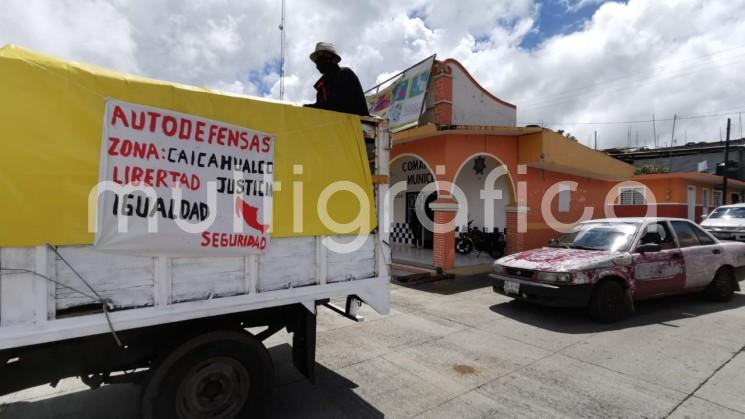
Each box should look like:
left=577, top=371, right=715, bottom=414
left=0, top=278, right=745, bottom=419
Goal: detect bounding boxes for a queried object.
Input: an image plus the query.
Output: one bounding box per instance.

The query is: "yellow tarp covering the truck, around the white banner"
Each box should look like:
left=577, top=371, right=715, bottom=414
left=0, top=46, right=376, bottom=246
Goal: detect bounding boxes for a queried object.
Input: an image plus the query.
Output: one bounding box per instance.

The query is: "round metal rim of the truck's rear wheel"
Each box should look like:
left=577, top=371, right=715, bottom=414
left=176, top=357, right=250, bottom=419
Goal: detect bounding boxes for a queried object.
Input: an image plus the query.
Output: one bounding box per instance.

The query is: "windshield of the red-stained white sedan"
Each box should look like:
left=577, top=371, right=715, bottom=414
left=549, top=222, right=639, bottom=252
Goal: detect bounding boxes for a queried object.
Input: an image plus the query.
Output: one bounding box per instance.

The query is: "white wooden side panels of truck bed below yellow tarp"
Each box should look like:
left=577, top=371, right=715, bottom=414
left=0, top=118, right=390, bottom=350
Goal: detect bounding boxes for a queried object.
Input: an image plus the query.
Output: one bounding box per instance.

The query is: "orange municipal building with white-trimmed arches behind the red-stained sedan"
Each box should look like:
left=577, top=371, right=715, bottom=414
left=390, top=59, right=745, bottom=269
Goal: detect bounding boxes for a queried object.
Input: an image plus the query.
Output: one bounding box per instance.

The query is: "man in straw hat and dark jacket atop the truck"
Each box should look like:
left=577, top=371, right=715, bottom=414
left=305, top=42, right=370, bottom=116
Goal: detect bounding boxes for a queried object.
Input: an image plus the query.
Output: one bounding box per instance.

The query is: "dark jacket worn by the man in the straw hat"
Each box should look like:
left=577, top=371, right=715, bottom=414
left=307, top=67, right=370, bottom=116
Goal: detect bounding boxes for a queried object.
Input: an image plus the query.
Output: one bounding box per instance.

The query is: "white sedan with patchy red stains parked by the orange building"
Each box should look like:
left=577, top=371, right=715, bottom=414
left=491, top=218, right=745, bottom=322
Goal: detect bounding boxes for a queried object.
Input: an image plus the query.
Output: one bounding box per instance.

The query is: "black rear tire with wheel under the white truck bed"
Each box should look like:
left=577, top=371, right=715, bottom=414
left=141, top=330, right=274, bottom=419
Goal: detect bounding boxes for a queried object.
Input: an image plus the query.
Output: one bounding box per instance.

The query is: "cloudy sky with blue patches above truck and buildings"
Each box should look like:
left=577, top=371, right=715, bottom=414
left=0, top=0, right=745, bottom=147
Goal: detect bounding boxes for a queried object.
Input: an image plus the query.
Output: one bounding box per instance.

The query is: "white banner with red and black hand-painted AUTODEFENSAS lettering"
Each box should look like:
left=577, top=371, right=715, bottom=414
left=95, top=99, right=275, bottom=256
